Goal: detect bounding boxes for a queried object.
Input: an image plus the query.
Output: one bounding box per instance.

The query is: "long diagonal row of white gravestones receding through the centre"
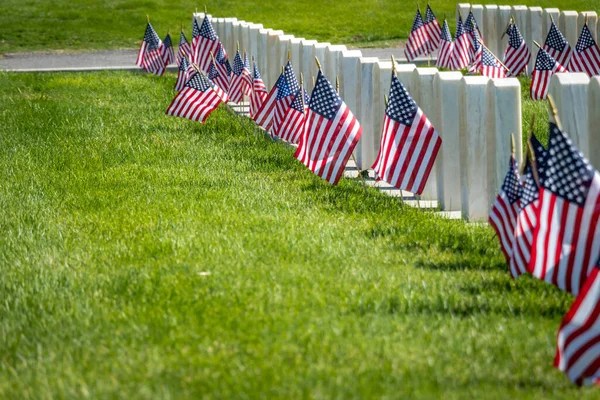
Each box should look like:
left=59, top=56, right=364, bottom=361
left=195, top=13, right=522, bottom=221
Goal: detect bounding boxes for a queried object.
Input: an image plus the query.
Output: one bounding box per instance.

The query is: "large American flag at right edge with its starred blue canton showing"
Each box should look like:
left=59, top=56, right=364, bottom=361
left=528, top=124, right=600, bottom=295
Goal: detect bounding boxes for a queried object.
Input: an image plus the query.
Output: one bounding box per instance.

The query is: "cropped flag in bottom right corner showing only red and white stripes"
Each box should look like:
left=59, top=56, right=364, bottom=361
left=554, top=263, right=600, bottom=386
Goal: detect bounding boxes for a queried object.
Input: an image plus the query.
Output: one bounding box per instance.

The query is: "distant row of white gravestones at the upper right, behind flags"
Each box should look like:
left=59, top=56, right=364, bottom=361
left=456, top=3, right=600, bottom=73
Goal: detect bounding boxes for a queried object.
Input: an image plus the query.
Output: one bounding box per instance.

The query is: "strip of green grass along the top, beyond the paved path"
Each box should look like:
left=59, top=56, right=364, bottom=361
left=0, top=0, right=600, bottom=53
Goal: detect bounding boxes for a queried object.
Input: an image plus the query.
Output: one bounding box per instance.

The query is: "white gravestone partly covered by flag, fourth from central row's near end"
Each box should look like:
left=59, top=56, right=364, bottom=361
left=411, top=68, right=438, bottom=200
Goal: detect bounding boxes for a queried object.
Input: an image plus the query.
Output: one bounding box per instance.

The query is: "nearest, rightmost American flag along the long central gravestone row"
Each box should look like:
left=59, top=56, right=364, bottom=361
left=372, top=71, right=442, bottom=194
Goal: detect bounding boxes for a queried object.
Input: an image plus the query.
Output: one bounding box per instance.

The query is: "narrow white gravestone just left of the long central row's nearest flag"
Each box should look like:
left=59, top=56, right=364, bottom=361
left=356, top=57, right=379, bottom=169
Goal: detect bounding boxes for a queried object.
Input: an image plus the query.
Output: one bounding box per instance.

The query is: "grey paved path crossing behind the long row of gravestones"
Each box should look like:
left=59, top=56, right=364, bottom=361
left=0, top=48, right=427, bottom=72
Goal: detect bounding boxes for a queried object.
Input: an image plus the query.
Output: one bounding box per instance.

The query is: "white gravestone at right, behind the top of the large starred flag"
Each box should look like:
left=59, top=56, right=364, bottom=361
left=548, top=72, right=598, bottom=159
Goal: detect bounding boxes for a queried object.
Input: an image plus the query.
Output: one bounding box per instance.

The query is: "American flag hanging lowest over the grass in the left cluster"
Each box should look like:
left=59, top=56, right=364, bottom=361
left=166, top=73, right=221, bottom=123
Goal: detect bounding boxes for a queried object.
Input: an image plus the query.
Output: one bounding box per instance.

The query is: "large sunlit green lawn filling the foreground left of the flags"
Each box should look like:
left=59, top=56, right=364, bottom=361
left=0, top=72, right=598, bottom=399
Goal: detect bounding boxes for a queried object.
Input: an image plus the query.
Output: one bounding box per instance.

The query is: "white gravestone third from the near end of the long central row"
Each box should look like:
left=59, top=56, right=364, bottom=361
left=429, top=71, right=463, bottom=211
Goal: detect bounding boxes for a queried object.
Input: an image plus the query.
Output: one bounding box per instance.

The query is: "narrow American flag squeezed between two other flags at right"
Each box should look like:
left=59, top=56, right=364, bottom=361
left=510, top=134, right=546, bottom=278
